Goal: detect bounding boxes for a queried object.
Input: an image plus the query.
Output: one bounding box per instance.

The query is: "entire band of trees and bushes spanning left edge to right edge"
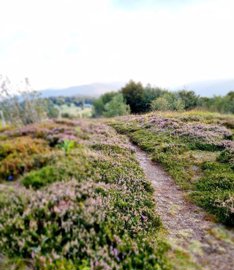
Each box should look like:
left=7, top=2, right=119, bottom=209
left=0, top=77, right=234, bottom=125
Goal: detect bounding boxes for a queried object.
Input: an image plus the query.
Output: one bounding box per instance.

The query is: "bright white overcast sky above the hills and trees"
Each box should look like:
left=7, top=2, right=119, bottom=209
left=0, top=0, right=234, bottom=90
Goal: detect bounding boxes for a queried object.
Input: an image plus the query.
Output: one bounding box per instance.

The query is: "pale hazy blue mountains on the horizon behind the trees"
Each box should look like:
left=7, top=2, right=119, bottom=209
left=40, top=79, right=234, bottom=97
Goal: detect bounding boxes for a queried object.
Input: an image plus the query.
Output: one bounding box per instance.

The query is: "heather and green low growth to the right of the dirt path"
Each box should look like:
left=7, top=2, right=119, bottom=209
left=111, top=111, right=234, bottom=226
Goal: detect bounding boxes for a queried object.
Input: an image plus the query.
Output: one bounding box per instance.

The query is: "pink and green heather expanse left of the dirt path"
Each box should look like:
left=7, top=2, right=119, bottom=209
left=0, top=120, right=170, bottom=270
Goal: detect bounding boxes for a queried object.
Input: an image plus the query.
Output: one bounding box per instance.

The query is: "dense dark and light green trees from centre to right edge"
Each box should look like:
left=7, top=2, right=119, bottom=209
left=93, top=81, right=234, bottom=117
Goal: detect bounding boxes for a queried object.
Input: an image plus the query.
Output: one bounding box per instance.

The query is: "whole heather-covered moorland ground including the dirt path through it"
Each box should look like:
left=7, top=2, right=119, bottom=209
left=0, top=112, right=234, bottom=270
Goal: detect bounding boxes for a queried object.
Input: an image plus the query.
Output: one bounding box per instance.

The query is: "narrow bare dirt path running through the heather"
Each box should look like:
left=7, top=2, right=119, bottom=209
left=133, top=146, right=234, bottom=270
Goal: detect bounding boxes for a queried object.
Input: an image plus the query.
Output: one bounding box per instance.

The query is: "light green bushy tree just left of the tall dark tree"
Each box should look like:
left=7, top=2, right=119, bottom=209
left=103, top=93, right=130, bottom=117
